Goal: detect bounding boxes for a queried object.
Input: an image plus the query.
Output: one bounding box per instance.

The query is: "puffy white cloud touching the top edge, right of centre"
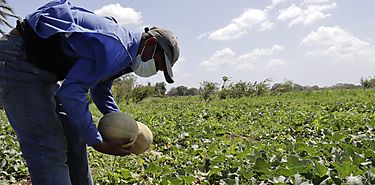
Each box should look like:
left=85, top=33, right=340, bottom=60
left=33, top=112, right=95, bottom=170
left=277, top=0, right=337, bottom=26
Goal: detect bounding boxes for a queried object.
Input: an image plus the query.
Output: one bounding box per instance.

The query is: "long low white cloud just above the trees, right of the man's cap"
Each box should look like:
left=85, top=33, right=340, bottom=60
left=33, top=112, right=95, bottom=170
left=200, top=45, right=283, bottom=71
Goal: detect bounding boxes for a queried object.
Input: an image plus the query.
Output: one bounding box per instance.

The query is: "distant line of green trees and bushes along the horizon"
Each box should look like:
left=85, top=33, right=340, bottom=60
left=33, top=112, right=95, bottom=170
left=97, top=74, right=375, bottom=103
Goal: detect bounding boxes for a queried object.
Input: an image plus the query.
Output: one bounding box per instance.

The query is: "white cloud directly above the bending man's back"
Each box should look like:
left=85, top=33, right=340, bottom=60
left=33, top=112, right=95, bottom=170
left=94, top=3, right=142, bottom=25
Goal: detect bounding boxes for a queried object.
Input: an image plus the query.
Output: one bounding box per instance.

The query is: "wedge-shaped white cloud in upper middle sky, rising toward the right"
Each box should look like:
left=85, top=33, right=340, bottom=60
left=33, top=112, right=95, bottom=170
left=208, top=9, right=273, bottom=40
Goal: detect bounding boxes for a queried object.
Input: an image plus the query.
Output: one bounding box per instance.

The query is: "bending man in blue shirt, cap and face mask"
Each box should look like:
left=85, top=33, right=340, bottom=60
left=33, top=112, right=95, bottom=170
left=0, top=0, right=179, bottom=185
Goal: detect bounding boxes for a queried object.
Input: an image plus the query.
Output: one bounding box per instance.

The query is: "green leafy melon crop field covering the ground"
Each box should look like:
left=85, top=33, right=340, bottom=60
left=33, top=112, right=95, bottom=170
left=0, top=90, right=375, bottom=185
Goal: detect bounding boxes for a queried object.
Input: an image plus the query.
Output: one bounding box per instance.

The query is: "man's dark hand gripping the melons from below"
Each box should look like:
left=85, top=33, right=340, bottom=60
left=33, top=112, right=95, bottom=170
left=93, top=139, right=133, bottom=156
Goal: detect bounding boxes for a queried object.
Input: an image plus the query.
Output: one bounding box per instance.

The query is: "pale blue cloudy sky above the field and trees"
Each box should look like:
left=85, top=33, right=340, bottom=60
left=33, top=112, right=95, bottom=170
left=8, top=0, right=375, bottom=88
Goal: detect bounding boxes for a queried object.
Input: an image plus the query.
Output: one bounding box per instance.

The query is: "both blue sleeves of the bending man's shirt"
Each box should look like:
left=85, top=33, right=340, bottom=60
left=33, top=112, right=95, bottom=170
left=57, top=33, right=130, bottom=146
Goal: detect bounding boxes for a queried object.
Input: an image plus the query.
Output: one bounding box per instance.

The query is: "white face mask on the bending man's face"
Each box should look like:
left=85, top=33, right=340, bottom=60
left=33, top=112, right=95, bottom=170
left=131, top=46, right=156, bottom=77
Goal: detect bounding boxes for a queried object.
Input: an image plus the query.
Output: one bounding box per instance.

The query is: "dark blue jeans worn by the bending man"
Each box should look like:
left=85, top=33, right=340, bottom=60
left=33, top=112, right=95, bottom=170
left=0, top=35, right=93, bottom=185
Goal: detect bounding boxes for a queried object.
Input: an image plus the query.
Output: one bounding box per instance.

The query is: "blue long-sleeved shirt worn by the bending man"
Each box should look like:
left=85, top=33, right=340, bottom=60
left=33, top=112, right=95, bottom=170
left=26, top=0, right=141, bottom=146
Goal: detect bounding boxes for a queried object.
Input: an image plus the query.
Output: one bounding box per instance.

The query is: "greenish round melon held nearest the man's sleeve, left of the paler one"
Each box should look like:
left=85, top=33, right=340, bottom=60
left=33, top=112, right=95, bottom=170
left=98, top=112, right=139, bottom=148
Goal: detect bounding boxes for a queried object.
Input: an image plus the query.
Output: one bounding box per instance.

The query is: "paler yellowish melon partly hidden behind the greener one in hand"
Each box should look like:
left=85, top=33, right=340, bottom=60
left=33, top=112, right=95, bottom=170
left=130, top=122, right=153, bottom=155
